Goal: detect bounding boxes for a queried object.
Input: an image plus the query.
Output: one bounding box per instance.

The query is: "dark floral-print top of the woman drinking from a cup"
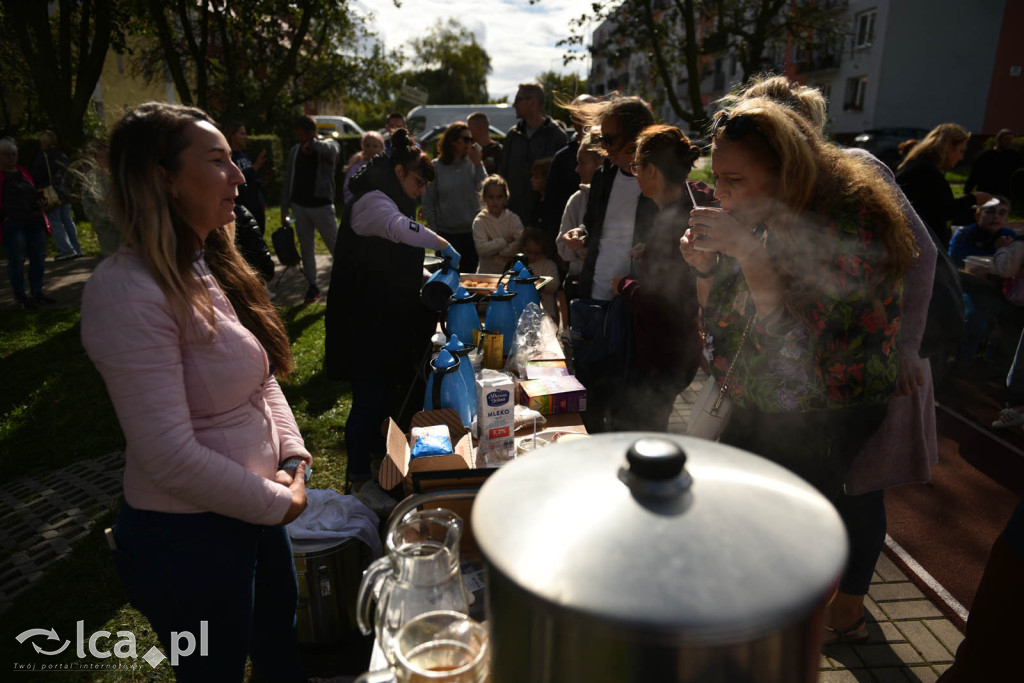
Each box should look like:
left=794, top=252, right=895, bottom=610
left=705, top=208, right=903, bottom=413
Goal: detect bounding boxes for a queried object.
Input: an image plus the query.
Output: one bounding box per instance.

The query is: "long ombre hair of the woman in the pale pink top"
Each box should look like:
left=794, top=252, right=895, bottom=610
left=110, top=102, right=293, bottom=378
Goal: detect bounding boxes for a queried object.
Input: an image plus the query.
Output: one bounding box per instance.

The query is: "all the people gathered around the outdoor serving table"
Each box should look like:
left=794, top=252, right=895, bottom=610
left=0, top=72, right=1024, bottom=681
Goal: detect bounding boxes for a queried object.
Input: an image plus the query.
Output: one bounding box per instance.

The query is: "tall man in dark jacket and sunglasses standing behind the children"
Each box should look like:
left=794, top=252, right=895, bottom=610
left=498, top=83, right=569, bottom=220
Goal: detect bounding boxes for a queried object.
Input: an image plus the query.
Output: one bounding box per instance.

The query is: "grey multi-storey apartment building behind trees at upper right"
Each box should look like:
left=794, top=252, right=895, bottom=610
left=590, top=0, right=1024, bottom=137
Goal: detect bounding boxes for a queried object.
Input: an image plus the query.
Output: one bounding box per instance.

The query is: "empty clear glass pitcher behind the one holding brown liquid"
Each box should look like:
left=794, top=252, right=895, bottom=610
left=356, top=510, right=469, bottom=665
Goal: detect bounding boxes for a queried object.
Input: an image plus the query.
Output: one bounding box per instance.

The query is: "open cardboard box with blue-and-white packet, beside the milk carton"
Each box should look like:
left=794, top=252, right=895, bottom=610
left=377, top=408, right=486, bottom=495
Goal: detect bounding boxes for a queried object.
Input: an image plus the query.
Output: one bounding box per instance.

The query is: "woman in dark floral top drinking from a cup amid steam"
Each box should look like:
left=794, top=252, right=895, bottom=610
left=681, top=98, right=914, bottom=498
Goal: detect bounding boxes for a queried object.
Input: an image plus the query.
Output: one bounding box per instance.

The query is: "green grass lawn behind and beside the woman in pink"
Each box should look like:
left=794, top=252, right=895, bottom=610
left=0, top=305, right=351, bottom=683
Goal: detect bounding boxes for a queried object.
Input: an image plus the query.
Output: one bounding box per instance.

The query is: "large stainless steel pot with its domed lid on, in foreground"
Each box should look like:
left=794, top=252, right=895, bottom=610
left=472, top=433, right=847, bottom=683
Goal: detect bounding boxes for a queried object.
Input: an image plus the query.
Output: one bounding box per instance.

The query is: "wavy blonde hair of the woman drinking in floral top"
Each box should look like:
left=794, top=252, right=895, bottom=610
left=713, top=98, right=916, bottom=323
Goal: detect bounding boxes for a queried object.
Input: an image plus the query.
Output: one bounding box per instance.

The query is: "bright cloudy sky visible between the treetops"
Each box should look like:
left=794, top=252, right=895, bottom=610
left=356, top=0, right=593, bottom=100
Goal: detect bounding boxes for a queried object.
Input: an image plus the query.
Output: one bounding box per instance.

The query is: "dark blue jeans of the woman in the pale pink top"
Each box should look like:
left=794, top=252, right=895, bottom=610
left=114, top=503, right=306, bottom=683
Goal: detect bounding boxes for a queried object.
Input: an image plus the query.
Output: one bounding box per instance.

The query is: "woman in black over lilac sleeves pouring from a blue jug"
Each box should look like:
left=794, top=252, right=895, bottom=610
left=324, top=128, right=461, bottom=488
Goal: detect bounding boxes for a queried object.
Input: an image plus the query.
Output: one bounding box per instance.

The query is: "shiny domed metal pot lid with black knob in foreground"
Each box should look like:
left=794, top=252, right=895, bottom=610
left=473, top=432, right=847, bottom=643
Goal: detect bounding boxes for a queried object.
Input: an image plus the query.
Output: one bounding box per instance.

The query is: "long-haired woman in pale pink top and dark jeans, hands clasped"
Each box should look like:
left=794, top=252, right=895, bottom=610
left=82, top=102, right=310, bottom=681
